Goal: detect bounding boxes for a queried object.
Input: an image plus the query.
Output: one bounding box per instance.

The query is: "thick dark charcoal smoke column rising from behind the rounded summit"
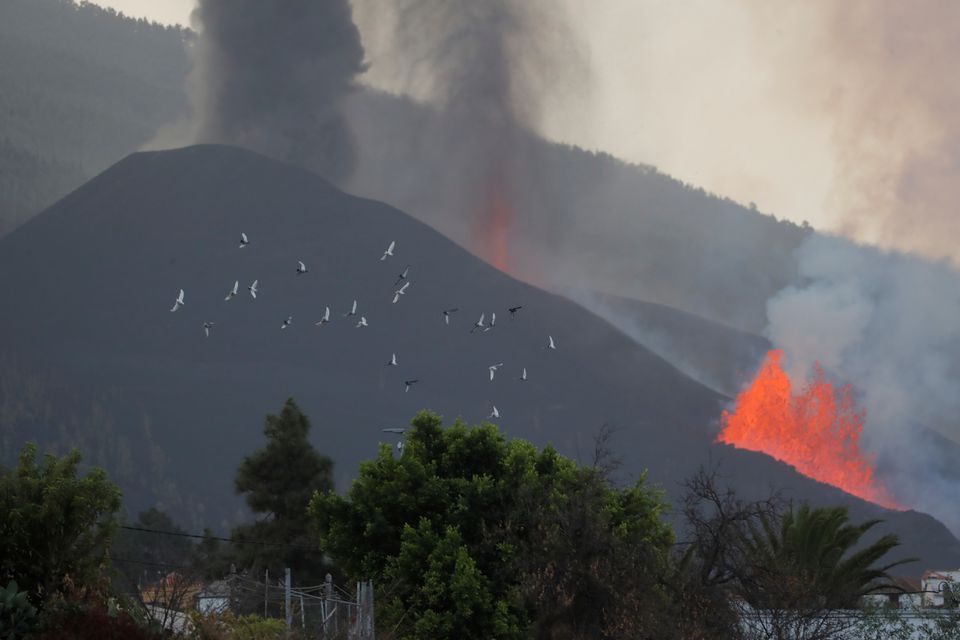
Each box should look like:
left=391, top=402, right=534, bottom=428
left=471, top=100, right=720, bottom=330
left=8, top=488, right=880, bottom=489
left=190, top=0, right=364, bottom=181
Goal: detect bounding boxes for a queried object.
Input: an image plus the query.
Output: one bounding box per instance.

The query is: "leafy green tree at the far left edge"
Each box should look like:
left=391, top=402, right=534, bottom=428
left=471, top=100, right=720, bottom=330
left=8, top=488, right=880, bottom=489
left=0, top=443, right=120, bottom=606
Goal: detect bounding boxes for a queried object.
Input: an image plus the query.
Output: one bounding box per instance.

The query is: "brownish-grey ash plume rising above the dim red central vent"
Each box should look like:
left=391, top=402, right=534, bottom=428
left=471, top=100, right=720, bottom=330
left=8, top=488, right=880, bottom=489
left=344, top=0, right=576, bottom=271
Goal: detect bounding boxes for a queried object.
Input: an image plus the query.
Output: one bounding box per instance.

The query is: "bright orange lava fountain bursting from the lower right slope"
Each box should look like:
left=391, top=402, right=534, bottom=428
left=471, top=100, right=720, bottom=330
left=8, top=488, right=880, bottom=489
left=717, top=351, right=901, bottom=509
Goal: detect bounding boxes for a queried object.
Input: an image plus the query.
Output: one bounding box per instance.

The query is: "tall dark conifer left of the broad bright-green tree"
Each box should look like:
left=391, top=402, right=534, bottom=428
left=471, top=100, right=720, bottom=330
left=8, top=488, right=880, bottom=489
left=232, top=398, right=333, bottom=582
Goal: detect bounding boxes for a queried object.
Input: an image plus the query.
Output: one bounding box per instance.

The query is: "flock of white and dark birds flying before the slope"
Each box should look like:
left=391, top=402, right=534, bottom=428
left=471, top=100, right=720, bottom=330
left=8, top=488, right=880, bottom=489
left=170, top=232, right=557, bottom=424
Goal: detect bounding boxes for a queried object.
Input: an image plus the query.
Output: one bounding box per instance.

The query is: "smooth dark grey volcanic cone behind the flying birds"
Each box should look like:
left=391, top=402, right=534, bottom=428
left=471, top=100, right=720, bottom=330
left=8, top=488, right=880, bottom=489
left=0, top=146, right=960, bottom=566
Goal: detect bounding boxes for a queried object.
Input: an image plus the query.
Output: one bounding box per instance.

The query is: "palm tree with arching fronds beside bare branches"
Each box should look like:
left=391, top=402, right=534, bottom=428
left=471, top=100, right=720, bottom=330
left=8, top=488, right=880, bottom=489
left=742, top=504, right=913, bottom=609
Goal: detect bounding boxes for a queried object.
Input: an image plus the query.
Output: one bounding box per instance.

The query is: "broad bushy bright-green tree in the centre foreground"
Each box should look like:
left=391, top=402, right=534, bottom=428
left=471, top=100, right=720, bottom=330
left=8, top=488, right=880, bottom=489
left=311, top=412, right=673, bottom=639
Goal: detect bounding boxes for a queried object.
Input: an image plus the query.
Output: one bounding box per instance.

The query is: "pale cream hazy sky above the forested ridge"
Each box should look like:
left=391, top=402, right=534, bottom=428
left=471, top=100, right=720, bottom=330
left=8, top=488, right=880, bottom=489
left=92, top=0, right=960, bottom=264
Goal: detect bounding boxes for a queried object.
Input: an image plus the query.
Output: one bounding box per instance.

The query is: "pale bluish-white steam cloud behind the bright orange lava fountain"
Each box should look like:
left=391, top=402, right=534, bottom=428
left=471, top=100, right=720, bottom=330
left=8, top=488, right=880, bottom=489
left=767, top=235, right=960, bottom=532
